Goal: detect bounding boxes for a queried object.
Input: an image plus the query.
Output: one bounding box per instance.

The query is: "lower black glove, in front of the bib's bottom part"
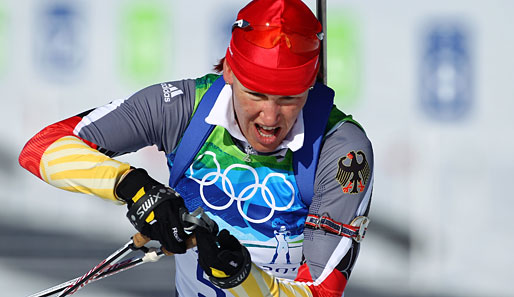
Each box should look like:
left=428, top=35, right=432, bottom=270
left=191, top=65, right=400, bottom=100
left=195, top=227, right=252, bottom=289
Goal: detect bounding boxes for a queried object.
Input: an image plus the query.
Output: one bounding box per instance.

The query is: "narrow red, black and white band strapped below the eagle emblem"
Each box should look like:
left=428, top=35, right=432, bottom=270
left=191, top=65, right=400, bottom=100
left=305, top=213, right=369, bottom=242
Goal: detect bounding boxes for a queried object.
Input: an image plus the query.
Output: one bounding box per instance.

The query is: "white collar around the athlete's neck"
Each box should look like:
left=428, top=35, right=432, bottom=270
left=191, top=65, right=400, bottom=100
left=205, top=84, right=304, bottom=152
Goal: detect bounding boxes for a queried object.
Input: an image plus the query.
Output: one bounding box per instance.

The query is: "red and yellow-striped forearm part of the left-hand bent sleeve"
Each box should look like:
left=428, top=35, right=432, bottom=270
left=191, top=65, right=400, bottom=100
left=19, top=111, right=130, bottom=201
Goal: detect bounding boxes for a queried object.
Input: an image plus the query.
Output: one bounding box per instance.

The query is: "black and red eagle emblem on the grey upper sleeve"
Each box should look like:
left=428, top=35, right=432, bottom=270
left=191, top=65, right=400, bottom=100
left=336, top=151, right=371, bottom=194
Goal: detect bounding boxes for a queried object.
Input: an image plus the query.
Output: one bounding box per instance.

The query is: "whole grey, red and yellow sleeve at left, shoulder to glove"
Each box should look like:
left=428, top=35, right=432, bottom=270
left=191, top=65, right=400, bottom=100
left=19, top=80, right=195, bottom=201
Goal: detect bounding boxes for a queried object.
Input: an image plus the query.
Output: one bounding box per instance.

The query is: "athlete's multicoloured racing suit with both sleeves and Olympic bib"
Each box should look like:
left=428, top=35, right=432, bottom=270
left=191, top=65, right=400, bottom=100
left=20, top=75, right=373, bottom=296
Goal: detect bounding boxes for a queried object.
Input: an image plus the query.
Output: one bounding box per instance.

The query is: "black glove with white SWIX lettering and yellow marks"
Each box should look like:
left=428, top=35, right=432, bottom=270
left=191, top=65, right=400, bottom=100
left=116, top=168, right=187, bottom=254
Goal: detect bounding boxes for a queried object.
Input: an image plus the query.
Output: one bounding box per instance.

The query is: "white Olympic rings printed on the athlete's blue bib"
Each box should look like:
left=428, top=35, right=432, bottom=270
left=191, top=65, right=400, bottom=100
left=189, top=151, right=295, bottom=224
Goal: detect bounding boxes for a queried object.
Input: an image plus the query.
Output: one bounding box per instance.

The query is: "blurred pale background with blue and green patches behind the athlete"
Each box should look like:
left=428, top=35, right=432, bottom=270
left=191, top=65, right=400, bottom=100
left=0, top=0, right=514, bottom=297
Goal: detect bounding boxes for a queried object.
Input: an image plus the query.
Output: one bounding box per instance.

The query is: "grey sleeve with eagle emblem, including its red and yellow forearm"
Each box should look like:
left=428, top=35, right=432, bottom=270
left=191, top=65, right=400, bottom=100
left=225, top=122, right=373, bottom=297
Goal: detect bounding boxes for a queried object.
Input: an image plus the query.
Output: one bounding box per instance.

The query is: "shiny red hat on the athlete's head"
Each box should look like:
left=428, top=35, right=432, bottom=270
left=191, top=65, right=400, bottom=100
left=225, top=0, right=322, bottom=95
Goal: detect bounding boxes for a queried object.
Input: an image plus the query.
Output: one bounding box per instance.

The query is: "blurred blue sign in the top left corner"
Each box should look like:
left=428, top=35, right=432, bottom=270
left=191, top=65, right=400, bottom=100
left=35, top=2, right=85, bottom=78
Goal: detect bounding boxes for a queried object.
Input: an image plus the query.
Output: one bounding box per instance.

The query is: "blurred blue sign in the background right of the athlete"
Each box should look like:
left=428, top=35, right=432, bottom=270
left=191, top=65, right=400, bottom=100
left=420, top=23, right=473, bottom=121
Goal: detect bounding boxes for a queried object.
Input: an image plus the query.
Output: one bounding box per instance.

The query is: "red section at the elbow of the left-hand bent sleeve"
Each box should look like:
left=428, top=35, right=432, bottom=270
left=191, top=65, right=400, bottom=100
left=18, top=116, right=97, bottom=179
